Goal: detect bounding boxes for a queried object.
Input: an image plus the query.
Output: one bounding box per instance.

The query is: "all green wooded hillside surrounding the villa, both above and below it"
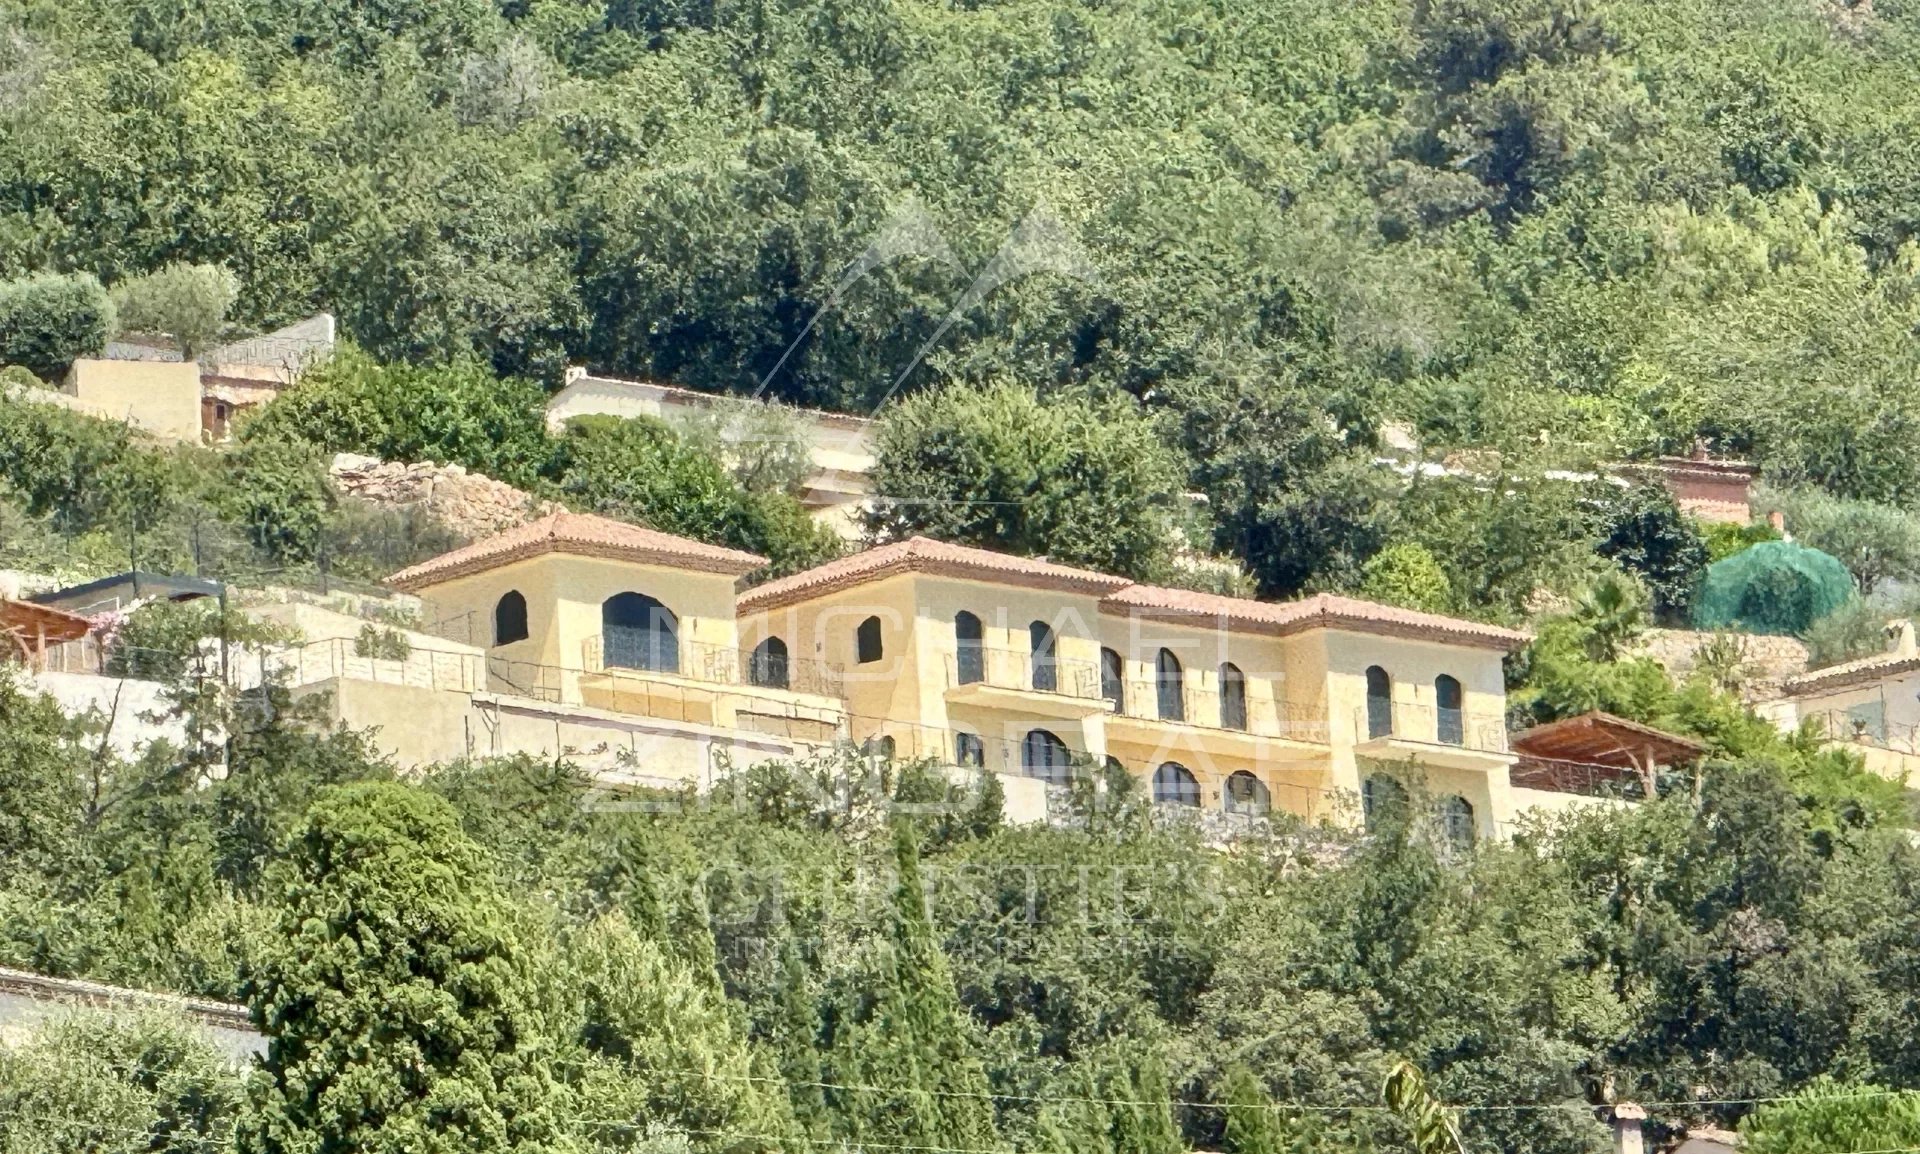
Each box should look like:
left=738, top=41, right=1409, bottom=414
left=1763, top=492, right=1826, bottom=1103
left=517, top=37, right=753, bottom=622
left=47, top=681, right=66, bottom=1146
left=15, top=0, right=1920, bottom=1154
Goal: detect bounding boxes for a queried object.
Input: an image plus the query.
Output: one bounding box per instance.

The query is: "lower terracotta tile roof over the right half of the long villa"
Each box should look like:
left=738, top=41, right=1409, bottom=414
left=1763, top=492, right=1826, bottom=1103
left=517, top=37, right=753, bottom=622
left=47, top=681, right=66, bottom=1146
left=1100, top=586, right=1532, bottom=651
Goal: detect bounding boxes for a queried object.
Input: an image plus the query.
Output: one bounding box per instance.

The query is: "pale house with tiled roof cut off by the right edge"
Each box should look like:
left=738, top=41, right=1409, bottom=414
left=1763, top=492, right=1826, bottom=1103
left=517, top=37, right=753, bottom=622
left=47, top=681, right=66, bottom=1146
left=1755, top=620, right=1920, bottom=781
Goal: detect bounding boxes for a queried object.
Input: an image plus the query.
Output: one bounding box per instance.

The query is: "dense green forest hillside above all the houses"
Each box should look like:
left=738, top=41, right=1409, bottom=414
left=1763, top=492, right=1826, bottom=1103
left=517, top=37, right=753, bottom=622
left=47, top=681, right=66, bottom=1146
left=0, top=0, right=1920, bottom=472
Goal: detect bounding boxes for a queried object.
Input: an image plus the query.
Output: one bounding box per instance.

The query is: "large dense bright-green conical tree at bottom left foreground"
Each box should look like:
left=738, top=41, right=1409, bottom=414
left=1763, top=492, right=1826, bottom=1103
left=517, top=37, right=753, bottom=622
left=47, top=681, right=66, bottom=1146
left=238, top=783, right=564, bottom=1154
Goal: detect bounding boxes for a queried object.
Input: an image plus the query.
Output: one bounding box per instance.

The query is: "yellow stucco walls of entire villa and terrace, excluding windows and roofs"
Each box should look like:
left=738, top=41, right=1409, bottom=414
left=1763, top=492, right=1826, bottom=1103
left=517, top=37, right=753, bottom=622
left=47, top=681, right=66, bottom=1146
left=303, top=541, right=1589, bottom=837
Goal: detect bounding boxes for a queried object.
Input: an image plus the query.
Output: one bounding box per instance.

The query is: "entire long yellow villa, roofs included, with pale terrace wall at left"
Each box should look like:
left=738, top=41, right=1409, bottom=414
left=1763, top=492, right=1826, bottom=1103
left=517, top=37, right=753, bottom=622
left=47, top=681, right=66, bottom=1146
left=280, top=526, right=1559, bottom=837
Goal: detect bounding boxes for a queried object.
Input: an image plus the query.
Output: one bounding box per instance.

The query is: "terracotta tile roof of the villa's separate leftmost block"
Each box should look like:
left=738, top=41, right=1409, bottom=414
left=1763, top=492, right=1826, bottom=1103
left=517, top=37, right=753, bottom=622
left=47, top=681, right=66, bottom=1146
left=386, top=513, right=766, bottom=589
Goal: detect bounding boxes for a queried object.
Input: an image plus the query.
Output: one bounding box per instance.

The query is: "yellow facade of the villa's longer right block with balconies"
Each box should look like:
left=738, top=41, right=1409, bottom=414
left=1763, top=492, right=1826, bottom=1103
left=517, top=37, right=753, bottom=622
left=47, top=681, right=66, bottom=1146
left=739, top=560, right=1515, bottom=835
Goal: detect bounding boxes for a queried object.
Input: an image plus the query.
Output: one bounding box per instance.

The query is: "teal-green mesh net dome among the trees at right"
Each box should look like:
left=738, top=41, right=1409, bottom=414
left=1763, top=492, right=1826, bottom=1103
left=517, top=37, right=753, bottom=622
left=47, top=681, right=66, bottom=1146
left=1693, top=541, right=1853, bottom=636
